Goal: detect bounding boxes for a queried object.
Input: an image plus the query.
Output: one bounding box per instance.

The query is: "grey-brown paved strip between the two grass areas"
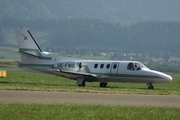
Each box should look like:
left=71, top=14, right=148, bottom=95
left=0, top=90, right=180, bottom=107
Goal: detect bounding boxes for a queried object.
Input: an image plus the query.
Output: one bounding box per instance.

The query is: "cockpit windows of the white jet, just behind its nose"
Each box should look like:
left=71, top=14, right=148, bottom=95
left=127, top=62, right=147, bottom=70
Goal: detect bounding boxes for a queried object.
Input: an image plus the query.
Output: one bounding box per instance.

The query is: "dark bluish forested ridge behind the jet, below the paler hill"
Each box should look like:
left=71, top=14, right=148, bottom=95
left=0, top=18, right=180, bottom=53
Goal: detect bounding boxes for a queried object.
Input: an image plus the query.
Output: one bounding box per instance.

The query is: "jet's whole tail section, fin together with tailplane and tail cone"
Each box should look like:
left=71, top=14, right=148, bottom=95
left=15, top=27, right=52, bottom=72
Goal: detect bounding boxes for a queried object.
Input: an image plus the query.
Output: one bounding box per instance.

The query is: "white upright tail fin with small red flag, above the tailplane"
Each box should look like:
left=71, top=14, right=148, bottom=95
left=15, top=27, right=51, bottom=62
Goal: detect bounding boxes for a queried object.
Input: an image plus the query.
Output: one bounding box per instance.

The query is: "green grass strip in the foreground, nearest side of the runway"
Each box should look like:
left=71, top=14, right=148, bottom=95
left=0, top=103, right=180, bottom=120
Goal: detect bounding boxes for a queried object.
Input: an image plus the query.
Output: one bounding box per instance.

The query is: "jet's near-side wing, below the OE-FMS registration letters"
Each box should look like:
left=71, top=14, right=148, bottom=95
left=48, top=69, right=100, bottom=78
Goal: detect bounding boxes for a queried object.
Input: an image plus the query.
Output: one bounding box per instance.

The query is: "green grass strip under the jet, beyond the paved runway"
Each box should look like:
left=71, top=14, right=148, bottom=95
left=0, top=68, right=180, bottom=95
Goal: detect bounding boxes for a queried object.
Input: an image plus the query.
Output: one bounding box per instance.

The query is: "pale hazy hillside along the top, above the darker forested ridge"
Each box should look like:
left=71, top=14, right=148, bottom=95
left=0, top=0, right=180, bottom=24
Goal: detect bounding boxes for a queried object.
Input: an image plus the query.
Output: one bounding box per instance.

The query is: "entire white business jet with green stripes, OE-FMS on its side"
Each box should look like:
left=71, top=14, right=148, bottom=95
left=16, top=27, right=172, bottom=89
